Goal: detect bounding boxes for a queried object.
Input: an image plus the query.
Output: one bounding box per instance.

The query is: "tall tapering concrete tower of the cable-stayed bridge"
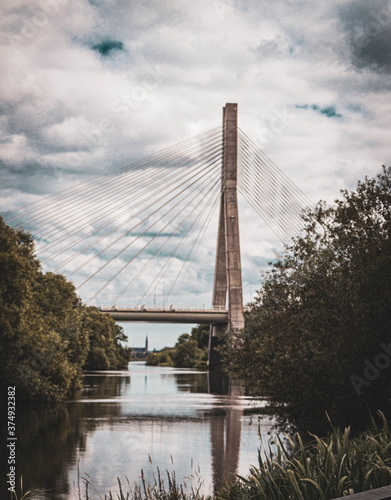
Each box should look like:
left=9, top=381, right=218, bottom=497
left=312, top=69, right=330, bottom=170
left=209, top=103, right=244, bottom=367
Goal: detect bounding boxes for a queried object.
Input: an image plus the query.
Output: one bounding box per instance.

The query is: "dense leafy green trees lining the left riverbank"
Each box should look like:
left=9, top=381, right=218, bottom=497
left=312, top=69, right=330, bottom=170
left=0, top=217, right=131, bottom=401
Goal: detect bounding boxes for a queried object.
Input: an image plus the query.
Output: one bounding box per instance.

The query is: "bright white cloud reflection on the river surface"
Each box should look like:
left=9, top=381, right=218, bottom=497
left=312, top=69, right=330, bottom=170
left=74, top=364, right=272, bottom=496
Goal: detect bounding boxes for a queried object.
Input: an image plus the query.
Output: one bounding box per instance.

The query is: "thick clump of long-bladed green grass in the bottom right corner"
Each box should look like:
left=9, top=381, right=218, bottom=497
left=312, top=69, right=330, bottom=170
left=221, top=415, right=391, bottom=500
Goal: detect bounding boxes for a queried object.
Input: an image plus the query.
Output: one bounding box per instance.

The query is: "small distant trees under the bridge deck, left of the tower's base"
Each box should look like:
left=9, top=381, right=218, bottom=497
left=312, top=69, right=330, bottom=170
left=146, top=325, right=209, bottom=368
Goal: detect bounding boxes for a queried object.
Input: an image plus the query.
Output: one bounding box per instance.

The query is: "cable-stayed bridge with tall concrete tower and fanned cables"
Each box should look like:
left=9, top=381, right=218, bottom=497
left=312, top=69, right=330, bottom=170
left=4, top=103, right=311, bottom=365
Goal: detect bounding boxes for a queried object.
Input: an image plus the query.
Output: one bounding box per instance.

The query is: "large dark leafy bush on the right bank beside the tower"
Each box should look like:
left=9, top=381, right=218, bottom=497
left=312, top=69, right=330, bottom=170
left=223, top=167, right=391, bottom=433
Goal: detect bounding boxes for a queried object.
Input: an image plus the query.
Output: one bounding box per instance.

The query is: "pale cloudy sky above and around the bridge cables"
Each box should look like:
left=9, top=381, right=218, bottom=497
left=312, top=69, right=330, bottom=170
left=0, top=0, right=391, bottom=347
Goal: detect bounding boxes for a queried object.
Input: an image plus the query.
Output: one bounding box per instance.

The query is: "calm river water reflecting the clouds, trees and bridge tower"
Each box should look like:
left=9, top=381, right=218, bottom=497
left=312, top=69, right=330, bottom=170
left=7, top=362, right=272, bottom=500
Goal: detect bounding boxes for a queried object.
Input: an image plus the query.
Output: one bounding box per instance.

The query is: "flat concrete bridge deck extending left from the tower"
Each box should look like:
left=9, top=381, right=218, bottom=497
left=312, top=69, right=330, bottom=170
left=99, top=307, right=228, bottom=324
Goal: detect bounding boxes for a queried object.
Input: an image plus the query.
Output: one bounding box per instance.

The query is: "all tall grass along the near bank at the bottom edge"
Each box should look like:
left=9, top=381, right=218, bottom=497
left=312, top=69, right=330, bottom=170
left=10, top=413, right=391, bottom=500
